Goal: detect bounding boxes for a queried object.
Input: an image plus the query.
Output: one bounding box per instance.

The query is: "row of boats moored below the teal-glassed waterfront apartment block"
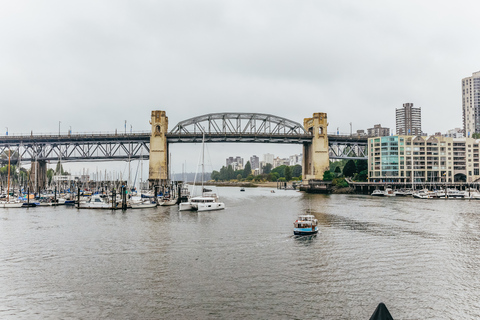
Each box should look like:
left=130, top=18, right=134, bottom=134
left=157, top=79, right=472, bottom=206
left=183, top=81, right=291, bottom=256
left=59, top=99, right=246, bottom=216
left=371, top=188, right=480, bottom=200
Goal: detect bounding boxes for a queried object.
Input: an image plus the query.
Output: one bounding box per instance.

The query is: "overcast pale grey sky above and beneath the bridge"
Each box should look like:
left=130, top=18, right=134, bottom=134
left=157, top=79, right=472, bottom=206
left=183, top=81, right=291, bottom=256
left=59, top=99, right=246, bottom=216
left=0, top=0, right=480, bottom=178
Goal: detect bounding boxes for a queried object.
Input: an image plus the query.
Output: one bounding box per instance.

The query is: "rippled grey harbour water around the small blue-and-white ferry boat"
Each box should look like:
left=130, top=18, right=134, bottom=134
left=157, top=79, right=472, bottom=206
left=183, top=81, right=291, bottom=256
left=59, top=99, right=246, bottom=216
left=0, top=188, right=480, bottom=319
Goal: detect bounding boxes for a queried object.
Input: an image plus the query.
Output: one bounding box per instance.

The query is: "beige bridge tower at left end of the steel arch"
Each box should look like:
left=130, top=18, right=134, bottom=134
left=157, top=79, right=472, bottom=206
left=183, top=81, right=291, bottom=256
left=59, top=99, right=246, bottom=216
left=148, top=110, right=168, bottom=188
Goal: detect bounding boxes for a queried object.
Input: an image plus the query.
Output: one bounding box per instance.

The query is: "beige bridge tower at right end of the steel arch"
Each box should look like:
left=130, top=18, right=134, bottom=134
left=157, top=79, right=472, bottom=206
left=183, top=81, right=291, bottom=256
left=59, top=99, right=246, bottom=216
left=302, top=113, right=330, bottom=180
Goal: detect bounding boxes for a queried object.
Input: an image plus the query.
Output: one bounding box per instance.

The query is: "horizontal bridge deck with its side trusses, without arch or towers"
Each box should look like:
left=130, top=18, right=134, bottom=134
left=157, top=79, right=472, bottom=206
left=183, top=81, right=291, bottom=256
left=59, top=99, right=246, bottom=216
left=0, top=131, right=367, bottom=162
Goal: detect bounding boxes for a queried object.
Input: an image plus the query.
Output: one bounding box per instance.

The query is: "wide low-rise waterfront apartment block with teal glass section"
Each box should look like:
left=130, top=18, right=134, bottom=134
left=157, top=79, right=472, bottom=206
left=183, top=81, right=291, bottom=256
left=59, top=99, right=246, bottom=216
left=368, top=135, right=480, bottom=184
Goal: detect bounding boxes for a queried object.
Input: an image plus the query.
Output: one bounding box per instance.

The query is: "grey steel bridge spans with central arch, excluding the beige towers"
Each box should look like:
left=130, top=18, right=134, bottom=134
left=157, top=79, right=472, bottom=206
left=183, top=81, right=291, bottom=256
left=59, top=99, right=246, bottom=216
left=0, top=113, right=367, bottom=163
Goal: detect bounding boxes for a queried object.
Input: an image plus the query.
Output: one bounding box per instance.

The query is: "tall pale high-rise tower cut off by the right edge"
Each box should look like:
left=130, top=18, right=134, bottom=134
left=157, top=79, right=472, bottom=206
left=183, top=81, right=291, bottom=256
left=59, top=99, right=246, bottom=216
left=462, top=71, right=480, bottom=137
